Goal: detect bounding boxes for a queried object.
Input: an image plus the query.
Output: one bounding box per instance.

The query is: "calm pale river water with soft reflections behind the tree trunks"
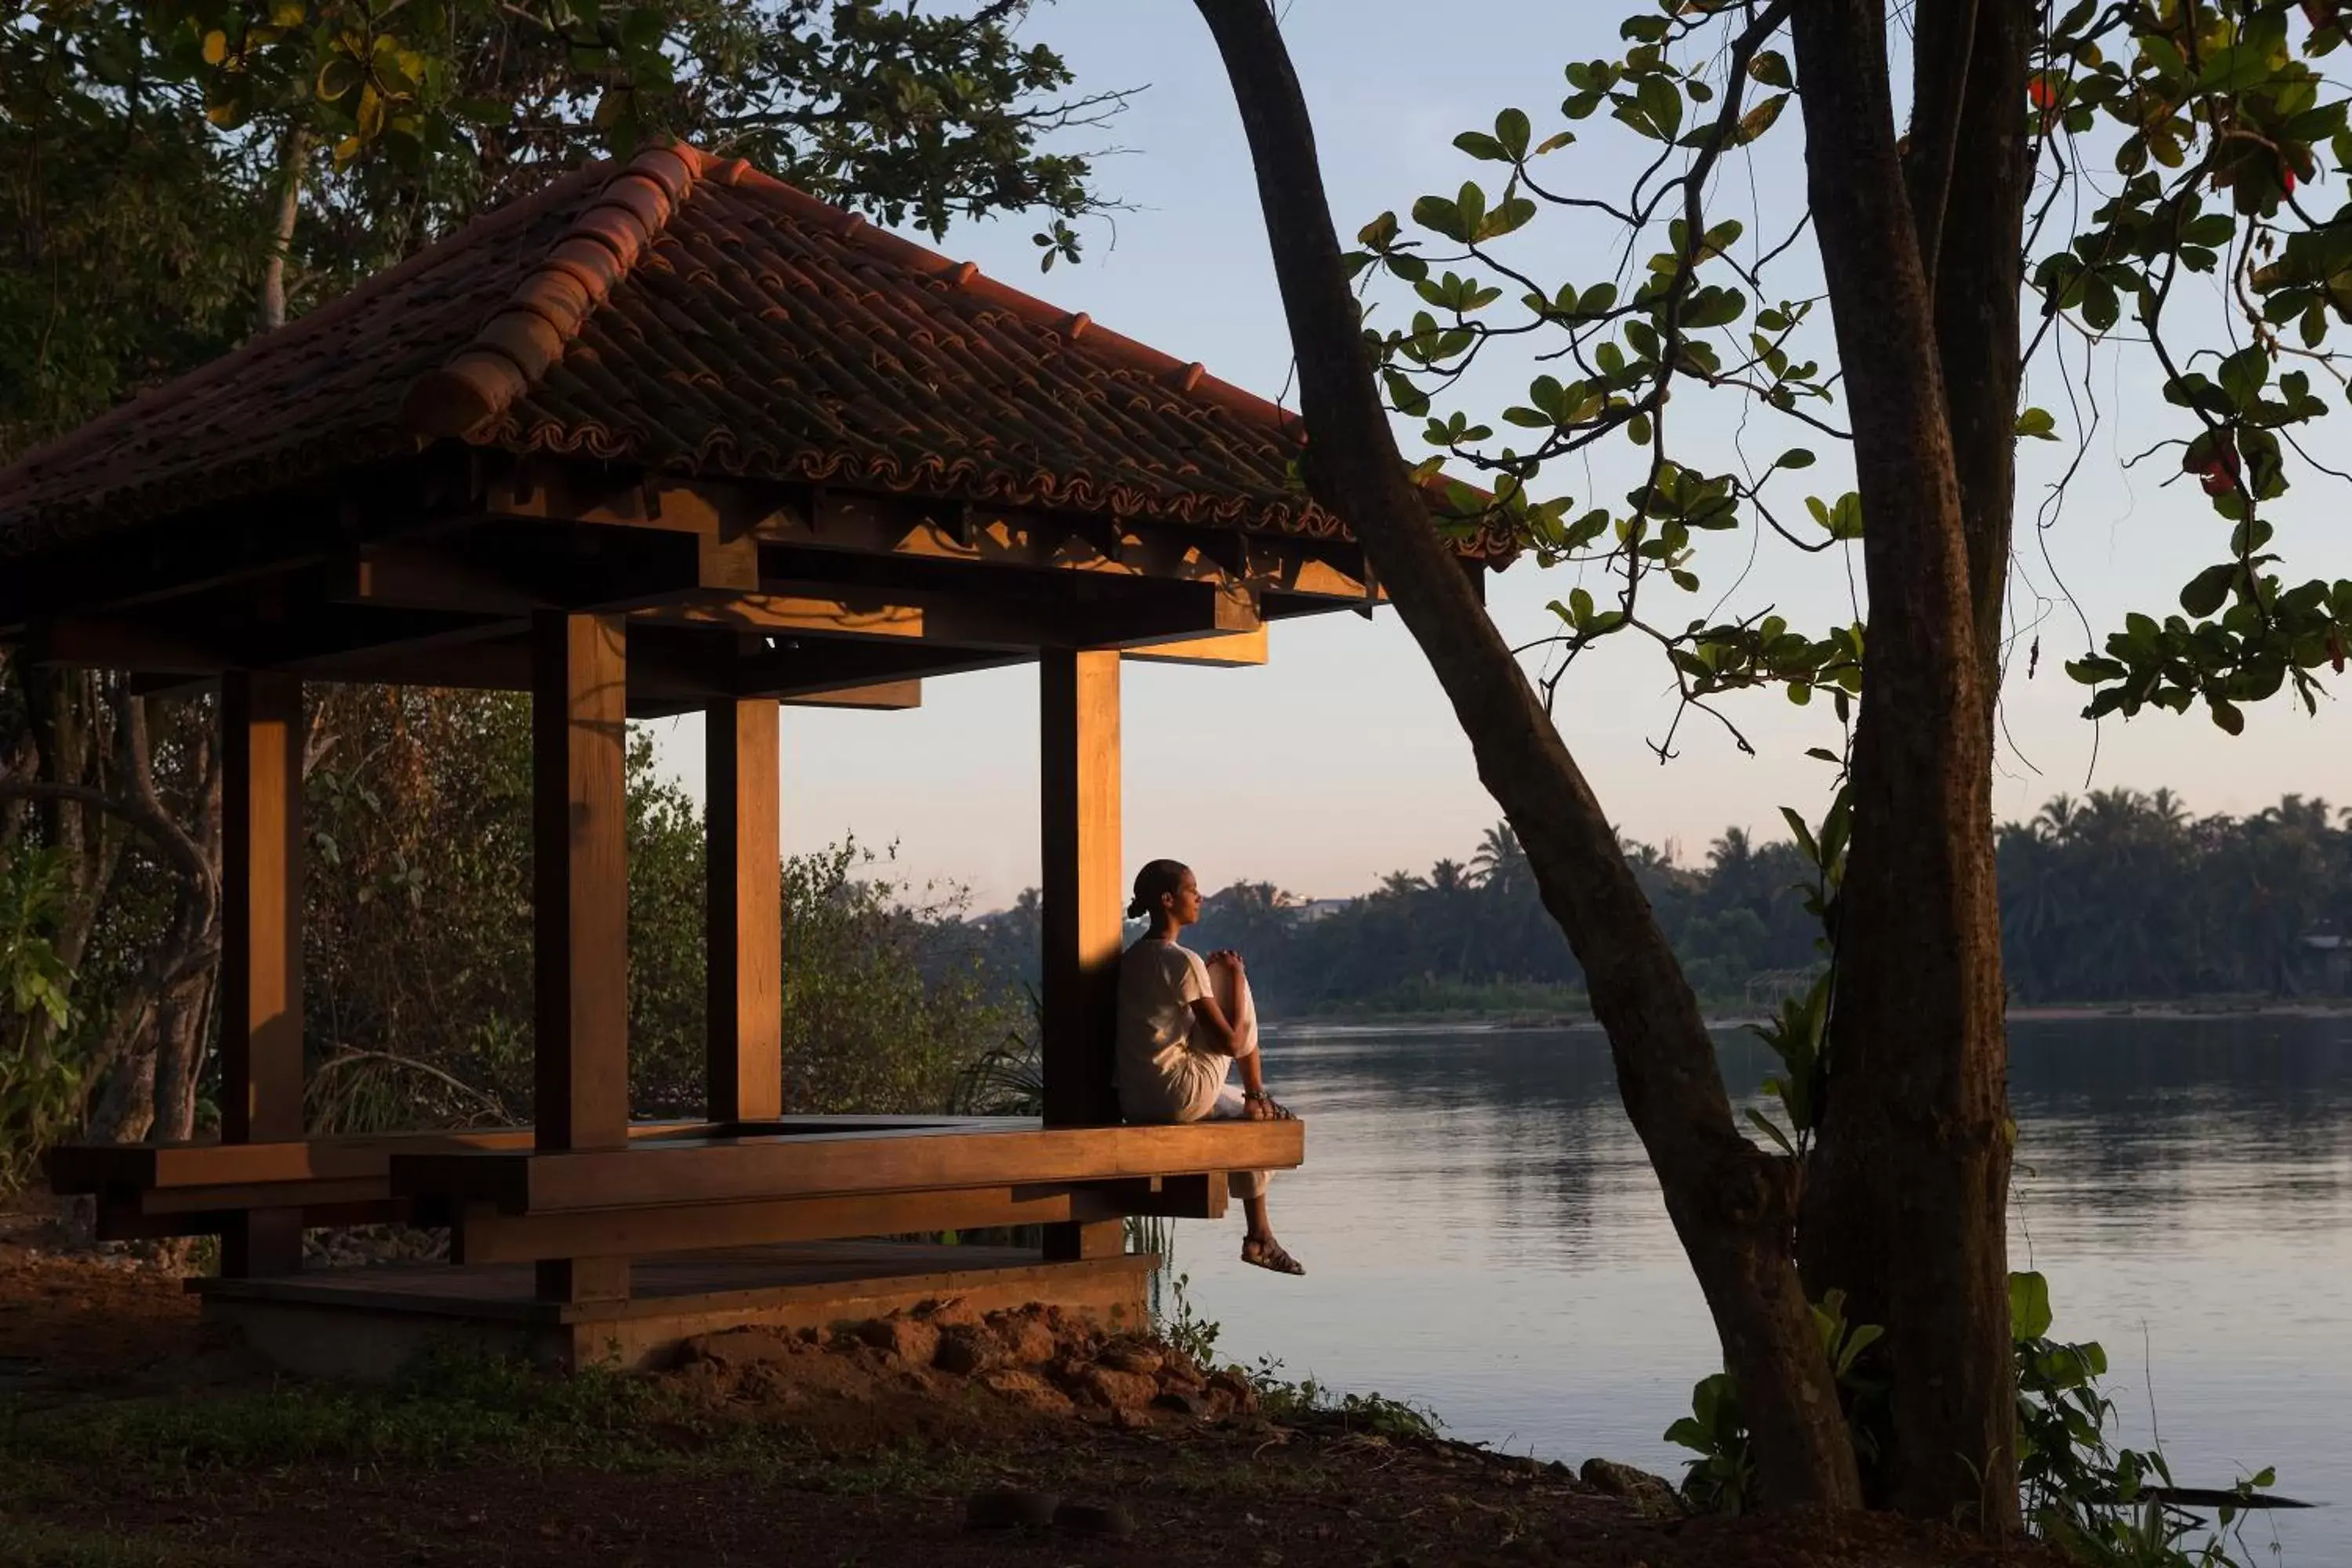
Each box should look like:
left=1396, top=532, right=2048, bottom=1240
left=1176, top=1018, right=2352, bottom=1566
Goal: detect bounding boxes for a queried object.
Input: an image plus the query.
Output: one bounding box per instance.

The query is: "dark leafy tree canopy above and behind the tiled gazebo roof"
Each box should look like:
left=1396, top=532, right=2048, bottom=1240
left=0, top=0, right=1127, bottom=456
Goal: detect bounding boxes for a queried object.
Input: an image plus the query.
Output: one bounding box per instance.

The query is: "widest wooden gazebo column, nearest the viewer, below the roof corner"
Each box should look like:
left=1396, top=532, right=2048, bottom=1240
left=532, top=612, right=628, bottom=1300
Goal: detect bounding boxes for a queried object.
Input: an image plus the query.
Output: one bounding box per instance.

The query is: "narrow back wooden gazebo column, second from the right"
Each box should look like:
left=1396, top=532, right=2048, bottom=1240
left=703, top=699, right=783, bottom=1121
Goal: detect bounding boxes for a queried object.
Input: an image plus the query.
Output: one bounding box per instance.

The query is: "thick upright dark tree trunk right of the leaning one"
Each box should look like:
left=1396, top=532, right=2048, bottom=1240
left=1795, top=0, right=2023, bottom=1533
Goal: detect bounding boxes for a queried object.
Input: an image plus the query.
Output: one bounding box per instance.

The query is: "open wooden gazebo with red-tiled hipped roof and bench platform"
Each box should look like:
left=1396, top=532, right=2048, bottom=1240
left=0, top=146, right=1486, bottom=1370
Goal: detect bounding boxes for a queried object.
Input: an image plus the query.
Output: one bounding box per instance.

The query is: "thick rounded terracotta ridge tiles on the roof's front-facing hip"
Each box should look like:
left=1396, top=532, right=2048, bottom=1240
left=400, top=143, right=710, bottom=437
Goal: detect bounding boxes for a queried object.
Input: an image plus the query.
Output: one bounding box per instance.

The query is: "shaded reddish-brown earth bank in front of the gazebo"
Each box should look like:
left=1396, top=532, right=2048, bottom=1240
left=0, top=1229, right=2051, bottom=1568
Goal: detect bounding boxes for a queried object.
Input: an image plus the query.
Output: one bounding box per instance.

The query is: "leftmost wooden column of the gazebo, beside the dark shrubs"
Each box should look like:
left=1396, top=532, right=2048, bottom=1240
left=221, top=670, right=303, bottom=1279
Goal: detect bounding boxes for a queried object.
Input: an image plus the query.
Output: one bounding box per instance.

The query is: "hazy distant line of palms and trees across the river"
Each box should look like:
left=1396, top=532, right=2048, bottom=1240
left=976, top=789, right=2352, bottom=1013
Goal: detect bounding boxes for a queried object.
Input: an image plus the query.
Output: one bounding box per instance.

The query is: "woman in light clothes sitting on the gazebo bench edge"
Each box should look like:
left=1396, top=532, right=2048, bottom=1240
left=1117, top=860, right=1305, bottom=1274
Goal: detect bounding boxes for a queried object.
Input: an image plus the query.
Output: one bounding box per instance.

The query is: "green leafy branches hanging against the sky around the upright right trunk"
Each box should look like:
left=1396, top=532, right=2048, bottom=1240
left=1348, top=0, right=2352, bottom=753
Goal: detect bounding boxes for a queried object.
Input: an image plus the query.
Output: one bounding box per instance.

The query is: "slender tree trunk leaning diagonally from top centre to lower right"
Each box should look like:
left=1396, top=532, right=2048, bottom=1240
left=1197, top=0, right=1860, bottom=1507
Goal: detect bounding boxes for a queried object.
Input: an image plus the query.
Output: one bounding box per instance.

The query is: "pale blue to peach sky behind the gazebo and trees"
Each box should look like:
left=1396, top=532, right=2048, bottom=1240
left=652, top=0, right=2352, bottom=909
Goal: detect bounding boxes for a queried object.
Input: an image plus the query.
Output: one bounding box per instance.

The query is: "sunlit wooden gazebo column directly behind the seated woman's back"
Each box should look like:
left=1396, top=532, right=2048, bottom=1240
left=1037, top=649, right=1127, bottom=1258
